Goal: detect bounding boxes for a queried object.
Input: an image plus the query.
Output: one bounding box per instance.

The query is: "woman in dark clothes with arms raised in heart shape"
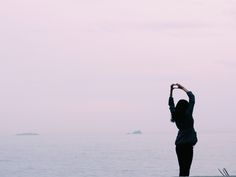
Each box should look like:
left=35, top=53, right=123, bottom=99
left=169, top=84, right=197, bottom=176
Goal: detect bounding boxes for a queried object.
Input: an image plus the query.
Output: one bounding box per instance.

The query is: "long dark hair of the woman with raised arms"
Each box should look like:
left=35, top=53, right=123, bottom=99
left=171, top=100, right=189, bottom=122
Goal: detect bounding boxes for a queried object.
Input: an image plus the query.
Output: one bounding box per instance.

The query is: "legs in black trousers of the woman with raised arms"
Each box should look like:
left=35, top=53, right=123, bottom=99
left=176, top=145, right=193, bottom=176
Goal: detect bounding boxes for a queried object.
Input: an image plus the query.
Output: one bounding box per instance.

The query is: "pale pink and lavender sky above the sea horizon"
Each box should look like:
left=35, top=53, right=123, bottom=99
left=0, top=0, right=236, bottom=134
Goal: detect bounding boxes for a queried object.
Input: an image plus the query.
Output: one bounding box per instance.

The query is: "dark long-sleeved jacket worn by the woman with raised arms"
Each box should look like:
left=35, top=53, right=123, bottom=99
left=169, top=91, right=197, bottom=145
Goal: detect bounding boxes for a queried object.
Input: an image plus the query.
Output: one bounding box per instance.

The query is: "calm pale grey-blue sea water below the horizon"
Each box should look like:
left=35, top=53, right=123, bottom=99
left=0, top=133, right=236, bottom=177
